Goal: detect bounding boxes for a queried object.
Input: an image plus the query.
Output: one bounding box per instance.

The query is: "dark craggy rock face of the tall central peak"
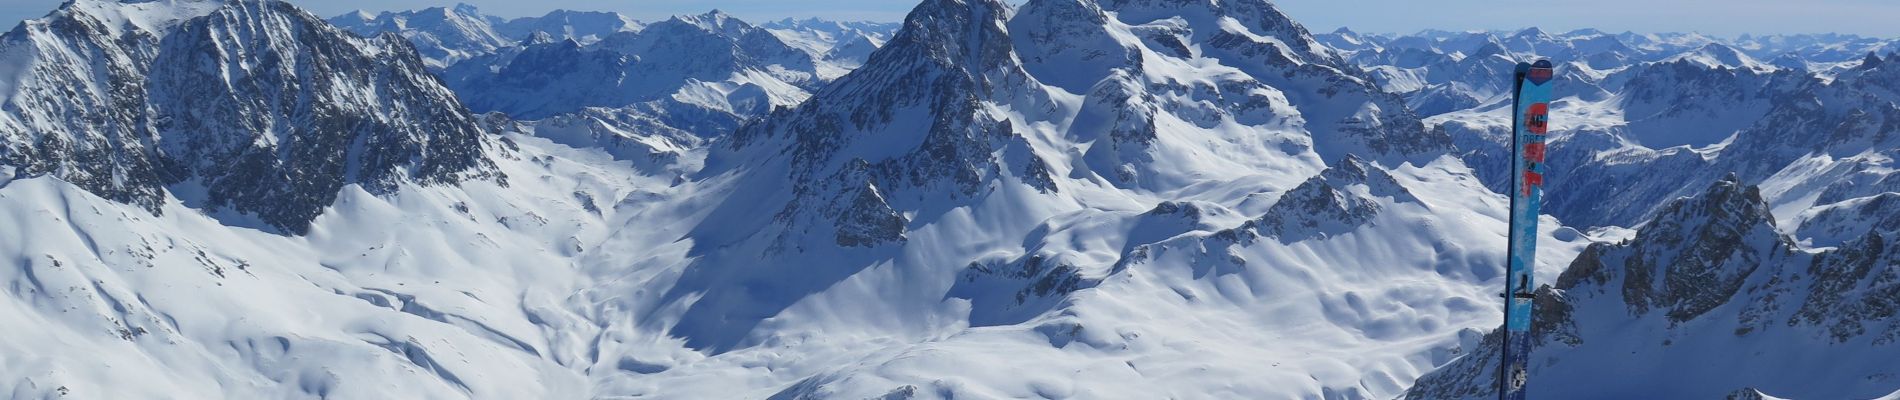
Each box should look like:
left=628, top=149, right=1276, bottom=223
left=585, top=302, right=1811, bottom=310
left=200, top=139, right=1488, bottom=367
left=714, top=0, right=1056, bottom=246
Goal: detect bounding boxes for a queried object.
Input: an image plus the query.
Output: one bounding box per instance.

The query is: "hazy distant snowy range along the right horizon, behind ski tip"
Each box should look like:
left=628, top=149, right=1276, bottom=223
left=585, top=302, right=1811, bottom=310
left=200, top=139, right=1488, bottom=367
left=1315, top=28, right=1900, bottom=114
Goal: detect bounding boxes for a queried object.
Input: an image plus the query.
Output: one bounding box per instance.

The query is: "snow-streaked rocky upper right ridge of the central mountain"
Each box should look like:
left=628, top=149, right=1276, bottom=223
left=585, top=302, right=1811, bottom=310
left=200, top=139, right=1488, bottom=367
left=1094, top=0, right=1450, bottom=165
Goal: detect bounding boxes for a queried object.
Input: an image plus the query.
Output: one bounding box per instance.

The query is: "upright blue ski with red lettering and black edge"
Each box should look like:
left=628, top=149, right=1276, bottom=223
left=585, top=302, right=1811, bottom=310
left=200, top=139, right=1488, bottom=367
left=1497, top=61, right=1552, bottom=400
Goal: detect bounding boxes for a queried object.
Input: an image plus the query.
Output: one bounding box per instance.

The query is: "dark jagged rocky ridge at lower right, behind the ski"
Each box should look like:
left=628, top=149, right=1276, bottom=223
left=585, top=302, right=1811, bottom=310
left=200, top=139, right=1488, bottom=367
left=1406, top=176, right=1900, bottom=398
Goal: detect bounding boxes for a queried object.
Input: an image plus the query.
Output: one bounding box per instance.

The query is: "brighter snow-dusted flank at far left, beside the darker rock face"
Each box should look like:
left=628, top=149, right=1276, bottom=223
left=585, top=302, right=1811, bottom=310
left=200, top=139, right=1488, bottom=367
left=0, top=0, right=220, bottom=210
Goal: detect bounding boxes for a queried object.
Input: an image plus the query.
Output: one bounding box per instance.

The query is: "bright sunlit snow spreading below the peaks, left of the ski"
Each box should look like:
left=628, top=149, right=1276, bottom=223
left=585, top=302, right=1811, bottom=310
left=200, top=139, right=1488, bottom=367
left=0, top=136, right=1587, bottom=398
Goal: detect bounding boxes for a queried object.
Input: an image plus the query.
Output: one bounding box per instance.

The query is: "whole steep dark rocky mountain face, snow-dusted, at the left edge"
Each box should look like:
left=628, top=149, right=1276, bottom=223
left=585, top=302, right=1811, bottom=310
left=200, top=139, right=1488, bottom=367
left=0, top=0, right=494, bottom=233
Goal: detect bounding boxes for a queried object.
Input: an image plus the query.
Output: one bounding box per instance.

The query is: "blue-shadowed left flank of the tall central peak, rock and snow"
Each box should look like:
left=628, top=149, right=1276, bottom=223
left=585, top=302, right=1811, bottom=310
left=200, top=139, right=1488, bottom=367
left=648, top=0, right=1056, bottom=353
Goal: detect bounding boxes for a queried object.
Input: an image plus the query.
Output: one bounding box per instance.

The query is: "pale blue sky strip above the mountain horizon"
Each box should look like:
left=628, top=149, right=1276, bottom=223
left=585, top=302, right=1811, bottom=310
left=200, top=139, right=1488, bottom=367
left=0, top=0, right=1900, bottom=38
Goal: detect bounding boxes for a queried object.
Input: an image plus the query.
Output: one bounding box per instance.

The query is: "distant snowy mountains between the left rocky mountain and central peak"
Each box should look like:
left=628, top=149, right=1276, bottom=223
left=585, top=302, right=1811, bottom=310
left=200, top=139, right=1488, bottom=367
left=333, top=4, right=897, bottom=188
